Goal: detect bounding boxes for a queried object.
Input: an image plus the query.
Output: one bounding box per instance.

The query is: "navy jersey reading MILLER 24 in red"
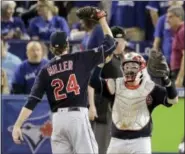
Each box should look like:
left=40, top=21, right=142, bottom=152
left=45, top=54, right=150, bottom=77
left=25, top=35, right=116, bottom=112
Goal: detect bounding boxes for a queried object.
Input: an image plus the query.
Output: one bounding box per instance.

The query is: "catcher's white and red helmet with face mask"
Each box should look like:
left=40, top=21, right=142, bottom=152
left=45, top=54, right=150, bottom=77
left=121, top=52, right=146, bottom=82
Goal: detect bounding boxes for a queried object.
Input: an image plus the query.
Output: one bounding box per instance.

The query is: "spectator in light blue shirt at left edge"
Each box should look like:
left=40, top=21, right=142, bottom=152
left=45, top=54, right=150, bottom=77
left=1, top=40, right=21, bottom=87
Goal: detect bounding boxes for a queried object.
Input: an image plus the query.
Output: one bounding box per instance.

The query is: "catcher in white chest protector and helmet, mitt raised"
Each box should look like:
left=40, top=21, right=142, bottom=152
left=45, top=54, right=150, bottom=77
left=91, top=50, right=178, bottom=154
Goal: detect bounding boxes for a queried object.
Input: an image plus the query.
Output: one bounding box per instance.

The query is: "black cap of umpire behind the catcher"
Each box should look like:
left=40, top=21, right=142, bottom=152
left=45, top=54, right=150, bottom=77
left=111, top=26, right=126, bottom=39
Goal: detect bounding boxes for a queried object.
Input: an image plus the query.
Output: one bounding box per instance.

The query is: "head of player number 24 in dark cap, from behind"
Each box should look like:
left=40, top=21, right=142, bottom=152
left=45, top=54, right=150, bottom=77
left=50, top=31, right=69, bottom=55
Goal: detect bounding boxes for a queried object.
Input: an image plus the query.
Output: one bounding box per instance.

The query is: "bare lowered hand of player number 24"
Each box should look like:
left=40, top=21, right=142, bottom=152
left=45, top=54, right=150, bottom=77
left=12, top=126, right=23, bottom=144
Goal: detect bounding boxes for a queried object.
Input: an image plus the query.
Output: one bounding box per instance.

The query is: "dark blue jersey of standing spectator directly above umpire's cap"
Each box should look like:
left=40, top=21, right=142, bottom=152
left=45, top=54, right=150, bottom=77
left=111, top=1, right=147, bottom=29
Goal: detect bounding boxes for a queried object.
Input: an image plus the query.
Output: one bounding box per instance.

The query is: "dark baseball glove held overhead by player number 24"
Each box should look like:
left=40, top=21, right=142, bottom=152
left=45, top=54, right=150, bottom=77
left=76, top=6, right=107, bottom=21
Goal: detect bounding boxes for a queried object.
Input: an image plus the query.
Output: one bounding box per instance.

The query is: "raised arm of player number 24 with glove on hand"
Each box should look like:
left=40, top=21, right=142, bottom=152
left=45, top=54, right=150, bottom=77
left=77, top=6, right=117, bottom=69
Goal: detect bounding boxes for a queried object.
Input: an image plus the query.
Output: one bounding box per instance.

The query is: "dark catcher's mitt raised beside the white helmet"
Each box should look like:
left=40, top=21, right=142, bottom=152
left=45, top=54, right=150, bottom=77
left=147, top=49, right=170, bottom=78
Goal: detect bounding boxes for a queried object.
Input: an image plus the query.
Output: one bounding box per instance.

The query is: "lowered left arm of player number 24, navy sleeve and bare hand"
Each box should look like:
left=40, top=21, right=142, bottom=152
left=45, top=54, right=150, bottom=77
left=12, top=69, right=45, bottom=144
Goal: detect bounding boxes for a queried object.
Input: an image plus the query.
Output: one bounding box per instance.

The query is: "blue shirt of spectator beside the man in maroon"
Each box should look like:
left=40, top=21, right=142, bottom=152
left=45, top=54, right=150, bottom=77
left=154, top=15, right=173, bottom=64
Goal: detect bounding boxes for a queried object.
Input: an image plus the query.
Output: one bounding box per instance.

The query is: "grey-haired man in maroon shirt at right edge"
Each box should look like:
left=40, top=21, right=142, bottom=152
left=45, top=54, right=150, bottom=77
left=167, top=6, right=185, bottom=87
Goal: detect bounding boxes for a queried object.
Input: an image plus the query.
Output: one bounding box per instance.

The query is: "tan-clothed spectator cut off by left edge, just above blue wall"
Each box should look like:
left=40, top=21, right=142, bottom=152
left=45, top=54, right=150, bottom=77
left=1, top=69, right=10, bottom=94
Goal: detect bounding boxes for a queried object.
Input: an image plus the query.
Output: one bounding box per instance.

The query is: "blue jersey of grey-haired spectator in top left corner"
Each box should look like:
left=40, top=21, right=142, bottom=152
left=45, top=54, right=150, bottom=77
left=1, top=17, right=26, bottom=35
